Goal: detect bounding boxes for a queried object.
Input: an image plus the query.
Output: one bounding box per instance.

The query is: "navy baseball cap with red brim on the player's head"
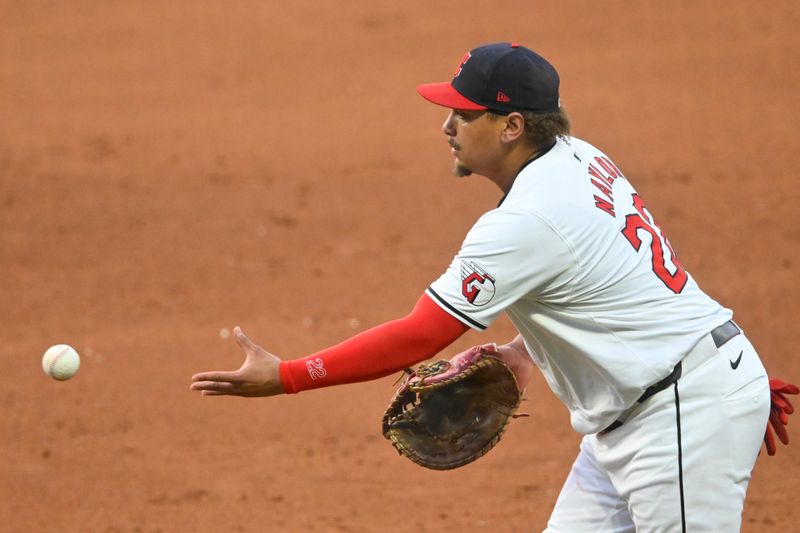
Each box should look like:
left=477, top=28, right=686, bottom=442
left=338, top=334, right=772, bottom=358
left=417, top=43, right=561, bottom=114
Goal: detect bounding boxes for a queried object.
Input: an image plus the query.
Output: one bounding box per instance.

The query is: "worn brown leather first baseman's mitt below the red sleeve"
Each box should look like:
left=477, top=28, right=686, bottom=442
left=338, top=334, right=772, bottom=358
left=383, top=344, right=520, bottom=470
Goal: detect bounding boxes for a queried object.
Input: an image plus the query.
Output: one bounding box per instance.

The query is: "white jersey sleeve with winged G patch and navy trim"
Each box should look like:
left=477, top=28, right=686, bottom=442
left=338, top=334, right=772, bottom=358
left=426, top=209, right=575, bottom=330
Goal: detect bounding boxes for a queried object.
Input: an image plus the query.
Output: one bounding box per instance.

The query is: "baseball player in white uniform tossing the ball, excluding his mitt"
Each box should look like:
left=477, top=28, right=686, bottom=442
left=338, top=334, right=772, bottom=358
left=191, top=43, right=790, bottom=533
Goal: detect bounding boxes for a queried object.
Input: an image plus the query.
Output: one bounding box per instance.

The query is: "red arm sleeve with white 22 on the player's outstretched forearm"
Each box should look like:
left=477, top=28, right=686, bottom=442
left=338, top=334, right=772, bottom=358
left=280, top=294, right=469, bottom=394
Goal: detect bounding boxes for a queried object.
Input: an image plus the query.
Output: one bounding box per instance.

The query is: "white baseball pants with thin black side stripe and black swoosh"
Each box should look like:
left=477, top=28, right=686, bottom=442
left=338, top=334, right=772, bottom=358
left=545, top=333, right=770, bottom=533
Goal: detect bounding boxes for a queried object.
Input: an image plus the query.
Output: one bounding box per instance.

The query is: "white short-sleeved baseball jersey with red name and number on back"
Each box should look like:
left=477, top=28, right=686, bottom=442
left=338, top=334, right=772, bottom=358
left=427, top=138, right=732, bottom=434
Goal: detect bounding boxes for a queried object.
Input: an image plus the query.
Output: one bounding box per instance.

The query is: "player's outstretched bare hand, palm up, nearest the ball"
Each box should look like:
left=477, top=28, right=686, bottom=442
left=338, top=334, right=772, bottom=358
left=189, top=326, right=283, bottom=397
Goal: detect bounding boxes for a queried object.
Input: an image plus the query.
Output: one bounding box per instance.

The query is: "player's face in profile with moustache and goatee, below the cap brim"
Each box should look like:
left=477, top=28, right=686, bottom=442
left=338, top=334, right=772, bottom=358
left=442, top=109, right=503, bottom=177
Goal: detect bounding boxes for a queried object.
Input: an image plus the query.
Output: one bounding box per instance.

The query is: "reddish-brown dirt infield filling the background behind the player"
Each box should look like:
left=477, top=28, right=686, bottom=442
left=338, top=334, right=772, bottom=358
left=0, top=0, right=800, bottom=533
